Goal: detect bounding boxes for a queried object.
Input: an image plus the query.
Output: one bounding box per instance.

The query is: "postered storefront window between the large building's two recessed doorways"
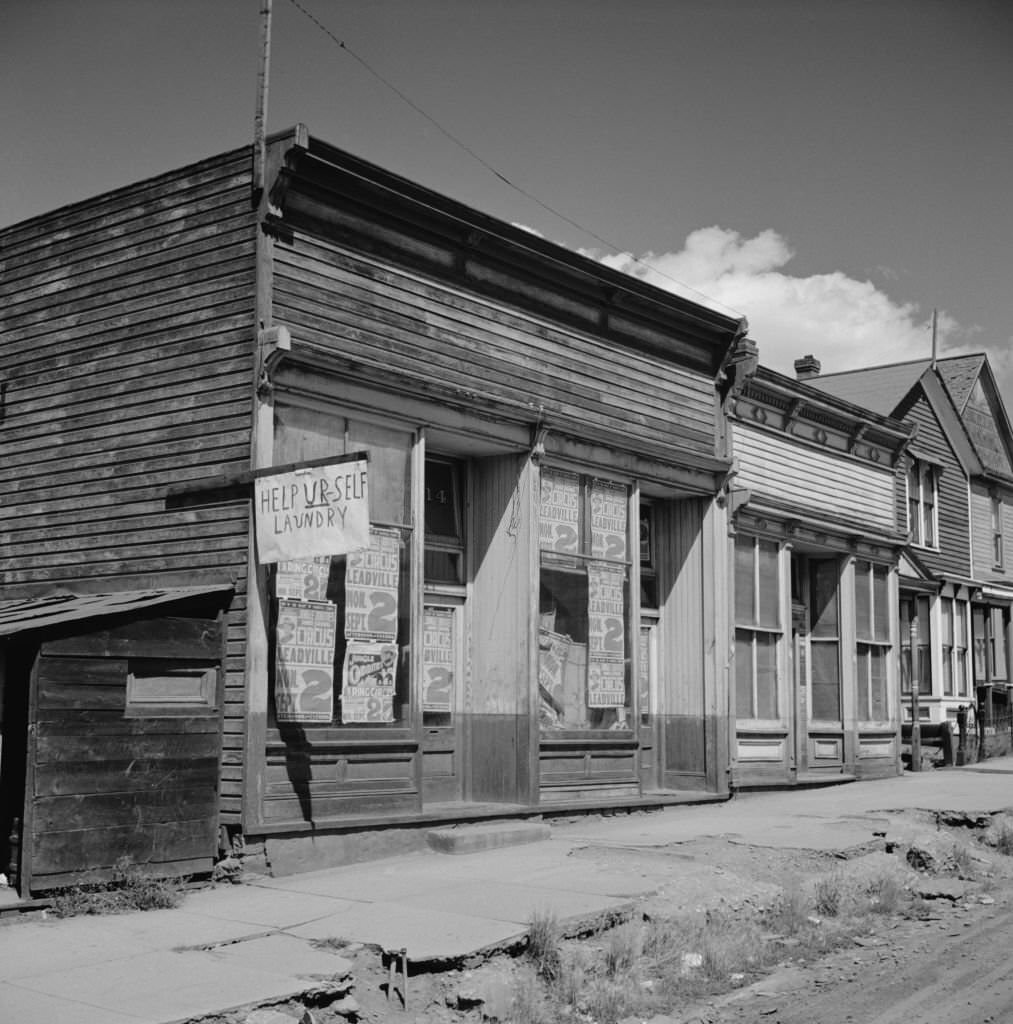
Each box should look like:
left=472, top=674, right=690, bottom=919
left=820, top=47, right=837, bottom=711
left=539, top=469, right=632, bottom=731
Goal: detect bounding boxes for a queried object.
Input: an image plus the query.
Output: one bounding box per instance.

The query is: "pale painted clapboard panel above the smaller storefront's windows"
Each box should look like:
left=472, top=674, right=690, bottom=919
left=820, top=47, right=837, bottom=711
left=731, top=423, right=895, bottom=528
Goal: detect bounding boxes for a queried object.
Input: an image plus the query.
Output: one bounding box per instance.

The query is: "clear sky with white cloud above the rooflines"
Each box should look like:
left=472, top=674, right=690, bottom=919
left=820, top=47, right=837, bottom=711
left=7, top=0, right=1013, bottom=416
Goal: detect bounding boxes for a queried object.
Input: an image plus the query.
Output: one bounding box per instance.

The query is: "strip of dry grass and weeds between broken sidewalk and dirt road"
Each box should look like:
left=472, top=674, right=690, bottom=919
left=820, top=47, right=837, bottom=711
left=511, top=858, right=930, bottom=1024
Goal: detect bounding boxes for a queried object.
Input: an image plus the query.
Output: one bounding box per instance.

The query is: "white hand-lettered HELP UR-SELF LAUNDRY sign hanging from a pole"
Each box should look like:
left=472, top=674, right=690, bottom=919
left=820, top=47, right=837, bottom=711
left=254, top=459, right=370, bottom=564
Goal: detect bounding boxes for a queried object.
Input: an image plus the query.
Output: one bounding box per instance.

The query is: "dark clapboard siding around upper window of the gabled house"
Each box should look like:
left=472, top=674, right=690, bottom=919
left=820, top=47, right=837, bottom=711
left=895, top=388, right=971, bottom=577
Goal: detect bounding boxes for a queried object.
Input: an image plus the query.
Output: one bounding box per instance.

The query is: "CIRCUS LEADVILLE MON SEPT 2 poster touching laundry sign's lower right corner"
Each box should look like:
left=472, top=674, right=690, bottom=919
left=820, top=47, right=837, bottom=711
left=345, top=526, right=400, bottom=643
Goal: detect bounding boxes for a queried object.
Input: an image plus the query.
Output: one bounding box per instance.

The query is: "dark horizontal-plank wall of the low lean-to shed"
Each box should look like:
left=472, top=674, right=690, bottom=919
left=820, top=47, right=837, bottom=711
left=26, top=617, right=222, bottom=891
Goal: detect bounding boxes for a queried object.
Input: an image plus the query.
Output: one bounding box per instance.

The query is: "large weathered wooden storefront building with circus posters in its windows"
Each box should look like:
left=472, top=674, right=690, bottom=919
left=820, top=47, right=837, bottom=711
left=0, top=127, right=745, bottom=892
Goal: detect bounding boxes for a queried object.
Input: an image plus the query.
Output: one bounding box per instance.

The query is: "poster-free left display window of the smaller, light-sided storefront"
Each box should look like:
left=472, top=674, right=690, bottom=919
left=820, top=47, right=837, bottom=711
left=735, top=537, right=782, bottom=719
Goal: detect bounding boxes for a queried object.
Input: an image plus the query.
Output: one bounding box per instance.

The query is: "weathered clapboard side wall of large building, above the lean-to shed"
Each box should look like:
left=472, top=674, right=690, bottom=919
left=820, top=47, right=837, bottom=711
left=0, top=150, right=256, bottom=814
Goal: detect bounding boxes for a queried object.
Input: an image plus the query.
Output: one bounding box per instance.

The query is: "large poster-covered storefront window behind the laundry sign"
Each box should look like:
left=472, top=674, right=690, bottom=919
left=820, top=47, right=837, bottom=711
left=270, top=407, right=414, bottom=730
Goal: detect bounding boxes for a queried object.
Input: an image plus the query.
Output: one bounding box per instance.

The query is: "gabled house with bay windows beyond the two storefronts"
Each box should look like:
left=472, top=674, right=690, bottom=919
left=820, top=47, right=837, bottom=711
left=806, top=355, right=1013, bottom=722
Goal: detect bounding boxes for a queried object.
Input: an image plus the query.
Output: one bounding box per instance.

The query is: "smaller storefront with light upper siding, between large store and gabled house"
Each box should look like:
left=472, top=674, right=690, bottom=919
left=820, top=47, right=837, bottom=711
left=728, top=357, right=912, bottom=787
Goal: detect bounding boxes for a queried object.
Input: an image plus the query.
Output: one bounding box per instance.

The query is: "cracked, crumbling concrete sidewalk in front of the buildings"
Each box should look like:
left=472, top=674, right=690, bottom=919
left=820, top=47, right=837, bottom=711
left=0, top=758, right=1013, bottom=1024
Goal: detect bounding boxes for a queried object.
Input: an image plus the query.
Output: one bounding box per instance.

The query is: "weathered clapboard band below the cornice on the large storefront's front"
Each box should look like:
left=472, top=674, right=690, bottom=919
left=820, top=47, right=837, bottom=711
left=275, top=232, right=715, bottom=455
